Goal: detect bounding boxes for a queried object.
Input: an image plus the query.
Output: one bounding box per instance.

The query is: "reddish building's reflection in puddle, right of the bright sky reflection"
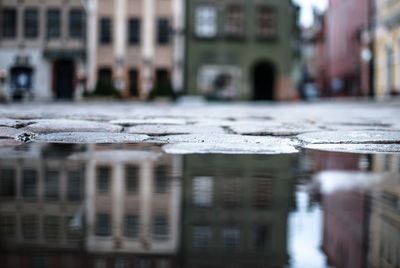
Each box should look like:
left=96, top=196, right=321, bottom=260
left=313, top=151, right=370, bottom=268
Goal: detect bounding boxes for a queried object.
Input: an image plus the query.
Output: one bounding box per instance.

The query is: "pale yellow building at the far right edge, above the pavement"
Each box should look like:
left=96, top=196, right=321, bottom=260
left=374, top=0, right=400, bottom=100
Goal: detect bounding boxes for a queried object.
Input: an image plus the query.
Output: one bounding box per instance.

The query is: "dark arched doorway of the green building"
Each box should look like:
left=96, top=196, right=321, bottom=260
left=253, top=62, right=275, bottom=100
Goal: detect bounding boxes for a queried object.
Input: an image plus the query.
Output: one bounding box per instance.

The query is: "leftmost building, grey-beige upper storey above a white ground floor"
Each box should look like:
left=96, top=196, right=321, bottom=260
left=0, top=0, right=86, bottom=100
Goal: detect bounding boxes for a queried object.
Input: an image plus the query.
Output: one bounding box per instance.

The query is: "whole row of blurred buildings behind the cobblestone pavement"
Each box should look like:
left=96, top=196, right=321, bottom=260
left=0, top=0, right=400, bottom=100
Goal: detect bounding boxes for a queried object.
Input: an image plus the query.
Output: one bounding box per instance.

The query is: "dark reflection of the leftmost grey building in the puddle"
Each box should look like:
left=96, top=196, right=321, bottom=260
left=0, top=144, right=85, bottom=267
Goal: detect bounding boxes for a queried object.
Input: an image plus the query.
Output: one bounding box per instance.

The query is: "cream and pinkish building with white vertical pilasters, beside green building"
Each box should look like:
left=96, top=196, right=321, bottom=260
left=87, top=0, right=184, bottom=98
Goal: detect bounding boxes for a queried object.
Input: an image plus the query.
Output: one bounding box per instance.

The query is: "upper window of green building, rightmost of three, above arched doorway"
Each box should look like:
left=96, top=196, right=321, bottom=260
left=257, top=7, right=277, bottom=39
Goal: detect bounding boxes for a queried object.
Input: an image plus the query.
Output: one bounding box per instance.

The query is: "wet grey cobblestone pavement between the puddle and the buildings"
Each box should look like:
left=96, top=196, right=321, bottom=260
left=0, top=101, right=400, bottom=154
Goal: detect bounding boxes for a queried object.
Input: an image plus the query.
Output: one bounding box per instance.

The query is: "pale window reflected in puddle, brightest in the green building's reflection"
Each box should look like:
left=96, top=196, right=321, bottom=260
left=193, top=177, right=213, bottom=207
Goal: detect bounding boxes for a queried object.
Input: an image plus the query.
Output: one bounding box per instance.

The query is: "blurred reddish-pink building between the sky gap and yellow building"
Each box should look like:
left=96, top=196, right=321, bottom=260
left=319, top=0, right=373, bottom=96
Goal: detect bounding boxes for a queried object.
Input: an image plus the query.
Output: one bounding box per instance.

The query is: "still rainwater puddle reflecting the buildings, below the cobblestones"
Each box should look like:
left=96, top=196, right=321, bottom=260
left=0, top=143, right=400, bottom=268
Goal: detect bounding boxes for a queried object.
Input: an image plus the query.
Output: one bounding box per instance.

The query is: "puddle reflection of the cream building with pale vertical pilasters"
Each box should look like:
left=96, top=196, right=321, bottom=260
left=83, top=145, right=180, bottom=264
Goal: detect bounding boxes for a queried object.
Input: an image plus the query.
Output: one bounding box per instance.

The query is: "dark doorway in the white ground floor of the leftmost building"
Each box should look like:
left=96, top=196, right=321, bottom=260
left=54, top=60, right=74, bottom=99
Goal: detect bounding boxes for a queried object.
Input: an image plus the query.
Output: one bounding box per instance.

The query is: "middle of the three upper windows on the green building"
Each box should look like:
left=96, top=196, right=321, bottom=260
left=225, top=5, right=244, bottom=38
